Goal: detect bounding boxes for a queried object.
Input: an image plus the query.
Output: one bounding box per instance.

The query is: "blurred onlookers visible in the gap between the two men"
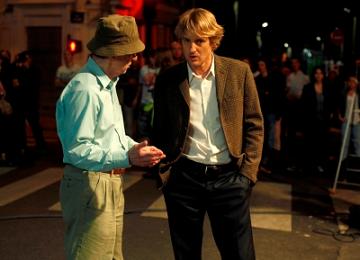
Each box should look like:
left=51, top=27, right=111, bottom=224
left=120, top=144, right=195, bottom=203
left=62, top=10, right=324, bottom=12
left=117, top=40, right=184, bottom=141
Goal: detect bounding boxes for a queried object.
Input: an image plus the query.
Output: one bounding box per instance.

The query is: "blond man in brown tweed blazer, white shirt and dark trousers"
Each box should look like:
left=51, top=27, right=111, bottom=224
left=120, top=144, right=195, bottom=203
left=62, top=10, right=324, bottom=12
left=153, top=8, right=264, bottom=260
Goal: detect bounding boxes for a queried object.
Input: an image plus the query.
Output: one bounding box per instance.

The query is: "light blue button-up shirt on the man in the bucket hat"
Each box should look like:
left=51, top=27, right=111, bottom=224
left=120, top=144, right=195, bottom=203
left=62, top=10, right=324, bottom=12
left=56, top=58, right=136, bottom=171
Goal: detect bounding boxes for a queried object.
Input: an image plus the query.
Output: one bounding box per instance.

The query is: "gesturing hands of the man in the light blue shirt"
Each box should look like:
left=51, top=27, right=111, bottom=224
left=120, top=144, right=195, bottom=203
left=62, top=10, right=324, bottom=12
left=128, top=140, right=165, bottom=167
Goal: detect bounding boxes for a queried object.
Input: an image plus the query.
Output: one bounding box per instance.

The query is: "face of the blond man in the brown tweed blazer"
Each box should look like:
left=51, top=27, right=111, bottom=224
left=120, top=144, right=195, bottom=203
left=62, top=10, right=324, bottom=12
left=181, top=32, right=213, bottom=75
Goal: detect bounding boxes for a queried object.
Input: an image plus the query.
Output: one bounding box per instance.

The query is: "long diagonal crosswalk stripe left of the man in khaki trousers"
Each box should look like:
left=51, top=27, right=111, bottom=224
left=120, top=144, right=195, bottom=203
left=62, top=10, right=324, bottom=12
left=0, top=168, right=63, bottom=206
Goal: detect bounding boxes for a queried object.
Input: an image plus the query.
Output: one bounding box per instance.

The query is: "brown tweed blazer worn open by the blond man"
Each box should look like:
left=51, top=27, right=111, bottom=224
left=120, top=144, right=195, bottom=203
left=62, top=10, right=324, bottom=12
left=153, top=55, right=264, bottom=182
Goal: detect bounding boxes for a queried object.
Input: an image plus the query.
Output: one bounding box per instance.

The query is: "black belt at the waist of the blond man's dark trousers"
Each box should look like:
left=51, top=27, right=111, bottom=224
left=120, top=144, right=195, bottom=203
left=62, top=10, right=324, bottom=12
left=176, top=156, right=237, bottom=177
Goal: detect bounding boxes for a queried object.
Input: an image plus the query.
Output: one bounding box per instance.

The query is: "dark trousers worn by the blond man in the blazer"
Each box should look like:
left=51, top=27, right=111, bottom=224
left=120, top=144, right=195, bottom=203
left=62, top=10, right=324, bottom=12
left=163, top=158, right=255, bottom=260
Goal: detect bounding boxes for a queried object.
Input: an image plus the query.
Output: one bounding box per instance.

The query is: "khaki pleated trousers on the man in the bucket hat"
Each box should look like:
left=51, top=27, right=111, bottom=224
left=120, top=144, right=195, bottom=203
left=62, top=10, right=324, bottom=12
left=60, top=165, right=124, bottom=260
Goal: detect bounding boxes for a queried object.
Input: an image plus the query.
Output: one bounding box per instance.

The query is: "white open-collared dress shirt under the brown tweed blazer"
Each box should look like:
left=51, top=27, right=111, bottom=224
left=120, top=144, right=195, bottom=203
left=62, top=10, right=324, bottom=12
left=184, top=58, right=231, bottom=165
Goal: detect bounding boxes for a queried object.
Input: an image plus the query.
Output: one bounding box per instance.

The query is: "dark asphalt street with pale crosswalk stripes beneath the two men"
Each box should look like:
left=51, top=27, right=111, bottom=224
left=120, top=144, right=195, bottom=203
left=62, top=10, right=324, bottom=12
left=0, top=138, right=360, bottom=260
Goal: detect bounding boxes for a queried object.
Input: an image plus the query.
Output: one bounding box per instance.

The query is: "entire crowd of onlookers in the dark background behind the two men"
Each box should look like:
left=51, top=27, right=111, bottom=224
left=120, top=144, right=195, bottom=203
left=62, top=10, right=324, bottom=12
left=0, top=41, right=360, bottom=177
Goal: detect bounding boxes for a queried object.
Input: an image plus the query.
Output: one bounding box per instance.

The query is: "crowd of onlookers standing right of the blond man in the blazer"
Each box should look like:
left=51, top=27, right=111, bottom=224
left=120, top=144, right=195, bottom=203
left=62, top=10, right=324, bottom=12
left=252, top=54, right=360, bottom=174
